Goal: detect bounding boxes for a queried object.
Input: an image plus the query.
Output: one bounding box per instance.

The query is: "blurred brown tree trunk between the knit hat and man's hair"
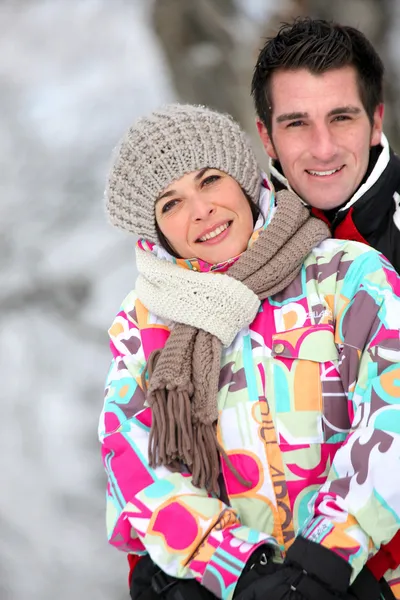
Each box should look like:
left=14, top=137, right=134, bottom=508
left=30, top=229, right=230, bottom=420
left=153, top=0, right=259, bottom=149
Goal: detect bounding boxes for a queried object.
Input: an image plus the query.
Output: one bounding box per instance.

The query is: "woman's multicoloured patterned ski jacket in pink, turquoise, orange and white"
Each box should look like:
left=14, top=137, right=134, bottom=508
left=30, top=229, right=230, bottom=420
left=99, top=226, right=400, bottom=598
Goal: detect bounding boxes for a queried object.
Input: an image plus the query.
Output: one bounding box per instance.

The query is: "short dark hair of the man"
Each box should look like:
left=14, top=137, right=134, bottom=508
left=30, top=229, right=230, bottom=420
left=251, top=17, right=384, bottom=133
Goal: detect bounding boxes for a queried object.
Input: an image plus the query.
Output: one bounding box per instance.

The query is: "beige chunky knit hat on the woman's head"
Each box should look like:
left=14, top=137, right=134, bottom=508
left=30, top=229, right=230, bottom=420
left=106, top=104, right=261, bottom=243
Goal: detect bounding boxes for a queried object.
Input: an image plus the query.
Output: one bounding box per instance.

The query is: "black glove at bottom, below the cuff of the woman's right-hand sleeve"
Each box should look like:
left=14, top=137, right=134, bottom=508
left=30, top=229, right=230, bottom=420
left=236, top=537, right=351, bottom=600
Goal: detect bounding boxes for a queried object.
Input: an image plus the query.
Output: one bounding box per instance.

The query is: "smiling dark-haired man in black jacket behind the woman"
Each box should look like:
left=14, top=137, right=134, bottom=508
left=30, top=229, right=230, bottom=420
left=252, top=18, right=400, bottom=271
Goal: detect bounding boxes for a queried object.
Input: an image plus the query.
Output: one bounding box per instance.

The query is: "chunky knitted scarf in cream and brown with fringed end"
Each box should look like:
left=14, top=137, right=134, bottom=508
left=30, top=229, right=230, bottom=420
left=136, top=190, right=330, bottom=494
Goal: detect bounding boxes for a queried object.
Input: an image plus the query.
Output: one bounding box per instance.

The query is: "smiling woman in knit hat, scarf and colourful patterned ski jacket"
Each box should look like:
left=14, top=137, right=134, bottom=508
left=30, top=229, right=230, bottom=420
left=100, top=105, right=400, bottom=600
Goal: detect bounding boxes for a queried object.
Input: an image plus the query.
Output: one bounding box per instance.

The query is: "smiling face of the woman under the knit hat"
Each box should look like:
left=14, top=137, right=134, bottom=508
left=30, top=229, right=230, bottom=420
left=155, top=168, right=253, bottom=264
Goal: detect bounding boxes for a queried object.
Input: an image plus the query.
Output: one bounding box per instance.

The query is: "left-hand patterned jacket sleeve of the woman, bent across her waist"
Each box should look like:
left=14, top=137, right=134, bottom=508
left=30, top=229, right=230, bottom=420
left=99, top=298, right=274, bottom=598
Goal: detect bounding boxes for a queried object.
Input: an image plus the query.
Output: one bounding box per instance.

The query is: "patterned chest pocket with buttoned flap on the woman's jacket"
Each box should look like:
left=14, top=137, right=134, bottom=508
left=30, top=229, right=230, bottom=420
left=272, top=324, right=350, bottom=445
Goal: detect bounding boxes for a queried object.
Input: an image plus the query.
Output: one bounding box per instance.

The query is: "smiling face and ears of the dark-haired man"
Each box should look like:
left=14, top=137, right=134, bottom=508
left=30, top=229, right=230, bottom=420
left=257, top=67, right=383, bottom=210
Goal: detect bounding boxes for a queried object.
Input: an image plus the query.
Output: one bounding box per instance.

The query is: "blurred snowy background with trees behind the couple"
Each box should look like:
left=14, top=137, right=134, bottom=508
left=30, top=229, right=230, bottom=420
left=0, top=0, right=400, bottom=600
